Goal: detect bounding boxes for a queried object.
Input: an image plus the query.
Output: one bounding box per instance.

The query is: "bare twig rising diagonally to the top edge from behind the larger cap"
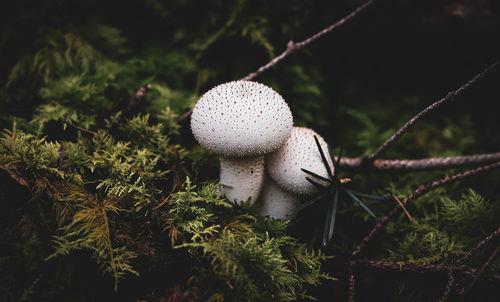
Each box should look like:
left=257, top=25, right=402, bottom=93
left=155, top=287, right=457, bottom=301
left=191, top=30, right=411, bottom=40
left=177, top=0, right=375, bottom=123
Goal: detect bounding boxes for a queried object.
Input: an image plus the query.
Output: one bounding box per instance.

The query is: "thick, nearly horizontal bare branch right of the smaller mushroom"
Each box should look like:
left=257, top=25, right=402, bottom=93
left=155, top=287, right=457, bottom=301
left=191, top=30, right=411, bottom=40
left=340, top=152, right=500, bottom=172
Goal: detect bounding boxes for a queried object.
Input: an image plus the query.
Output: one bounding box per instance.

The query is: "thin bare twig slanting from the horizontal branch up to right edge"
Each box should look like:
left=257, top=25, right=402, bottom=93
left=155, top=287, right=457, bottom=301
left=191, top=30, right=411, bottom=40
left=366, top=62, right=498, bottom=162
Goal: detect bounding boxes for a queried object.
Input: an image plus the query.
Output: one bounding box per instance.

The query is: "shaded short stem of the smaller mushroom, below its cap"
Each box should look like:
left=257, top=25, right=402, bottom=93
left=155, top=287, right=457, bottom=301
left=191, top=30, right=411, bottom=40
left=259, top=177, right=300, bottom=220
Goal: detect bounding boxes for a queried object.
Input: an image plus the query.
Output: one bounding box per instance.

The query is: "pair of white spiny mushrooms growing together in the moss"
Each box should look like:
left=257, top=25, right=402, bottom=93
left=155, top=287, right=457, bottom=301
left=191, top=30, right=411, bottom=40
left=191, top=81, right=333, bottom=219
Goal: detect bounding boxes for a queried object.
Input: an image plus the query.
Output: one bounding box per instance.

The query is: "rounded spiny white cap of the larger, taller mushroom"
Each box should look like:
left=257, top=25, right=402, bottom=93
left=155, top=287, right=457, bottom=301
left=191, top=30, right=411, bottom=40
left=191, top=81, right=293, bottom=158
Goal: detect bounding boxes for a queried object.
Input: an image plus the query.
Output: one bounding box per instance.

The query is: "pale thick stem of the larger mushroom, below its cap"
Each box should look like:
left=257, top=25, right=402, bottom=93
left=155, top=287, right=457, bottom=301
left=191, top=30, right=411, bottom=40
left=219, top=156, right=264, bottom=203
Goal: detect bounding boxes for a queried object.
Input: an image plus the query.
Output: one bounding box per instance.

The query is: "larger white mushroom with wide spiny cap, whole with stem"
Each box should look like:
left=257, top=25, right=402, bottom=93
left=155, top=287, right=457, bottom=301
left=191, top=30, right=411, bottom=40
left=191, top=81, right=293, bottom=202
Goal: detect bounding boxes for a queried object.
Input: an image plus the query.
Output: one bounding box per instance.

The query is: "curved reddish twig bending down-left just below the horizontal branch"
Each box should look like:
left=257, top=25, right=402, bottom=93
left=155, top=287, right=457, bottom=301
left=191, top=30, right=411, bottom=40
left=352, top=161, right=500, bottom=257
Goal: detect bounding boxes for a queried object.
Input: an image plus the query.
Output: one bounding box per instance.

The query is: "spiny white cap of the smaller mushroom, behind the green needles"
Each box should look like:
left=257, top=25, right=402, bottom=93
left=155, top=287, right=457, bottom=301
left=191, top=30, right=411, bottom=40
left=266, top=127, right=333, bottom=195
